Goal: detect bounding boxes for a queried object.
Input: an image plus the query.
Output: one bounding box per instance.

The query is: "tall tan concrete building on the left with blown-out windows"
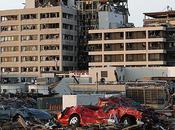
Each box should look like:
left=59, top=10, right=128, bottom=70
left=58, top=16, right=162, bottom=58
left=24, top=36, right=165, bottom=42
left=0, top=0, right=78, bottom=82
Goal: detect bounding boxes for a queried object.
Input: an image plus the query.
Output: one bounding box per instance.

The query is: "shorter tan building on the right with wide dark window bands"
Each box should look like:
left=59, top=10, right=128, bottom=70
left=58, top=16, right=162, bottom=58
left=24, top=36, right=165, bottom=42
left=88, top=10, right=175, bottom=67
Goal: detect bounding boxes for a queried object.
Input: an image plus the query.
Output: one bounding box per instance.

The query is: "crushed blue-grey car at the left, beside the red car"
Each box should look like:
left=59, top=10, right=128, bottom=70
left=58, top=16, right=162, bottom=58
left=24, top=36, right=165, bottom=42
left=0, top=100, right=52, bottom=125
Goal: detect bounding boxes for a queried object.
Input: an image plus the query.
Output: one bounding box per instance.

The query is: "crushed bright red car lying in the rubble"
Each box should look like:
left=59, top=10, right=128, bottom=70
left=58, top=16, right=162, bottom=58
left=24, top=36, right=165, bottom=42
left=58, top=97, right=158, bottom=127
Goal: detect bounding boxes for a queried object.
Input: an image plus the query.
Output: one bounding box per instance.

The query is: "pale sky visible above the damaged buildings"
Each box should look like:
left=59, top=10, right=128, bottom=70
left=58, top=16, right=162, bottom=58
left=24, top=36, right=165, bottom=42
left=0, top=0, right=175, bottom=26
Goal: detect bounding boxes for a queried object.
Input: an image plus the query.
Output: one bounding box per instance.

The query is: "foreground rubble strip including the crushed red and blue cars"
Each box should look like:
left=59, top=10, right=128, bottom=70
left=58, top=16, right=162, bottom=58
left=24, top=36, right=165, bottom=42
left=0, top=96, right=175, bottom=130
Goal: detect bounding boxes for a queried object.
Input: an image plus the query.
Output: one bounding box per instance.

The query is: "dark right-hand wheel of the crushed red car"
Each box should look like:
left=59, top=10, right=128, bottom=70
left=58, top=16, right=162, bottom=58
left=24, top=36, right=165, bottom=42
left=121, top=116, right=136, bottom=128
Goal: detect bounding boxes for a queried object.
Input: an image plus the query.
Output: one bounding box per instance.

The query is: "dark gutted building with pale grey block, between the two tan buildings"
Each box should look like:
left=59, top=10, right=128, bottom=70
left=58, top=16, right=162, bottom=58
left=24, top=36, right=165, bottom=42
left=76, top=0, right=129, bottom=70
